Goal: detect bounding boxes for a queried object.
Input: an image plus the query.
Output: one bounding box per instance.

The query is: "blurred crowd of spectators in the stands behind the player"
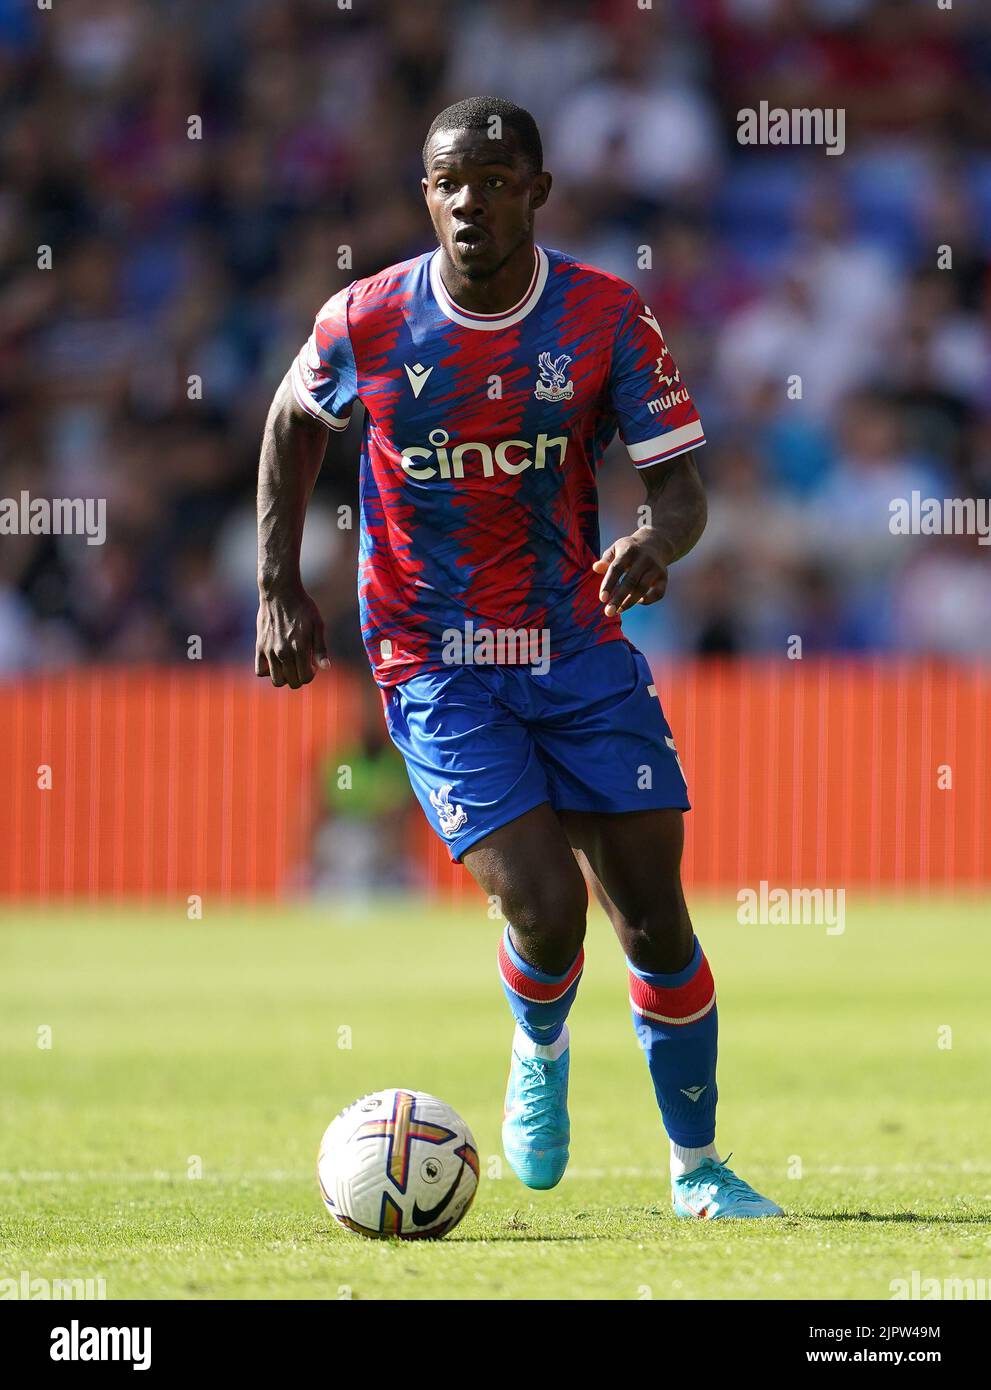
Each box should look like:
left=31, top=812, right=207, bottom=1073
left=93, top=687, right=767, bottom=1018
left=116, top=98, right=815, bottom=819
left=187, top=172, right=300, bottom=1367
left=0, top=0, right=991, bottom=676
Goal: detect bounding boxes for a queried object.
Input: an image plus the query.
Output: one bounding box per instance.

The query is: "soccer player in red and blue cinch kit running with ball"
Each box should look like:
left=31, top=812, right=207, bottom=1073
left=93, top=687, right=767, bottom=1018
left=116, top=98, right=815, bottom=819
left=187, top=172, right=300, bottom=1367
left=256, top=97, right=781, bottom=1219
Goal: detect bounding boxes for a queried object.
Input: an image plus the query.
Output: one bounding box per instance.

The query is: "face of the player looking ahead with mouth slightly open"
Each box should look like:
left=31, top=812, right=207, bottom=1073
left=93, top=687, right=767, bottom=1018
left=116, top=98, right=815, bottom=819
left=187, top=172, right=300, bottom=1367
left=423, top=131, right=550, bottom=279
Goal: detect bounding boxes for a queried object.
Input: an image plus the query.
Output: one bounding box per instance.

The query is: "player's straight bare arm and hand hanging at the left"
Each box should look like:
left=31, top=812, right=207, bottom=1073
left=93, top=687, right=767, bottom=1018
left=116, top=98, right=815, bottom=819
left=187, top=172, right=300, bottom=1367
left=254, top=375, right=329, bottom=689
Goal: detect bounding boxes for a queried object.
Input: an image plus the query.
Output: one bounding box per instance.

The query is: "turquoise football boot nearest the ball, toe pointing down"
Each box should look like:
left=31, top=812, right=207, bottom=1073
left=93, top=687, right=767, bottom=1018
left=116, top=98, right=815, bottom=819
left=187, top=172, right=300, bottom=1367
left=502, top=1026, right=571, bottom=1188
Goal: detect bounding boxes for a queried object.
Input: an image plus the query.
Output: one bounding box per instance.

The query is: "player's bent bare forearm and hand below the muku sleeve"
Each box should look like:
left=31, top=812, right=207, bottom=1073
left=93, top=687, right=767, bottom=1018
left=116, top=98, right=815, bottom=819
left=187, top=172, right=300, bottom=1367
left=592, top=450, right=706, bottom=617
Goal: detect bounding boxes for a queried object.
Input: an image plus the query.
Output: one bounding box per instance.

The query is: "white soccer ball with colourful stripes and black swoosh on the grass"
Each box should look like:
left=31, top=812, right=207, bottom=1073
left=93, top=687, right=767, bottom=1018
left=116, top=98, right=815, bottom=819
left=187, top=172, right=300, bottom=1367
left=317, top=1090, right=478, bottom=1240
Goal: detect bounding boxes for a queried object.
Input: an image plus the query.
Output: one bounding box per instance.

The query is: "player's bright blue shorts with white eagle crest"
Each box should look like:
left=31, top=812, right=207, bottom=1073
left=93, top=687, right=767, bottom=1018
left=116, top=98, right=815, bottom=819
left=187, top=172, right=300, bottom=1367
left=382, top=638, right=691, bottom=862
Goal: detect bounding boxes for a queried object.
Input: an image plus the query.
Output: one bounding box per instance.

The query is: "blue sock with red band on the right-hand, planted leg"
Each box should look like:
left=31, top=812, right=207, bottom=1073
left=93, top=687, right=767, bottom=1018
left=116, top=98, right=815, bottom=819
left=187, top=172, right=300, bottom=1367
left=627, top=937, right=719, bottom=1148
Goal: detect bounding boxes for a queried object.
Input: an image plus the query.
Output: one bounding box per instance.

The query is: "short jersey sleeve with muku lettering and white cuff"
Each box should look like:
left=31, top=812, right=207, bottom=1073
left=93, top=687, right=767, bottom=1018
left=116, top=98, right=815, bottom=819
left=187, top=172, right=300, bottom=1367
left=609, top=292, right=706, bottom=468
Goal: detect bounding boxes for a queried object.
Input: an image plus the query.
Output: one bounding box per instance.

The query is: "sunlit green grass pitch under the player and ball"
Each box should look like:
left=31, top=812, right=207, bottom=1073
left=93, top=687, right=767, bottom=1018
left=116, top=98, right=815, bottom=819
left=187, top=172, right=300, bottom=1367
left=0, top=891, right=991, bottom=1300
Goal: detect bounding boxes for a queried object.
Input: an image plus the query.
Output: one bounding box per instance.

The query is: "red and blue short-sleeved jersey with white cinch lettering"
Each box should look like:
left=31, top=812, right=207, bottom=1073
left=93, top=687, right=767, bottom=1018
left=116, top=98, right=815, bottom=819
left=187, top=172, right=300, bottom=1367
left=292, top=246, right=705, bottom=685
